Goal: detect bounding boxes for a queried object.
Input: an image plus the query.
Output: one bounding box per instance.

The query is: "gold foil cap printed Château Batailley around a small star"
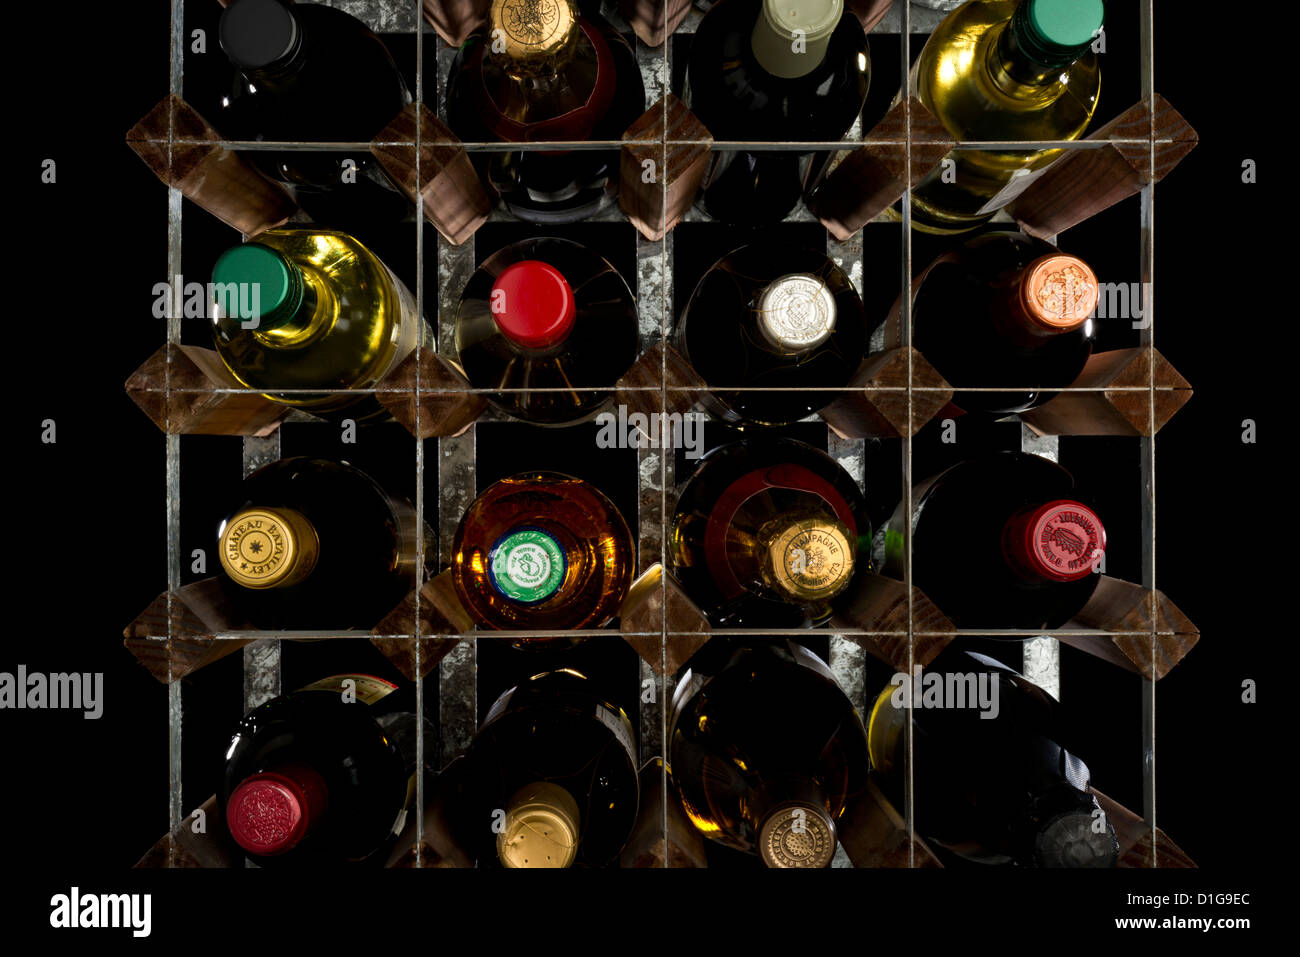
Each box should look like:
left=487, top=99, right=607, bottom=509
left=220, top=508, right=320, bottom=588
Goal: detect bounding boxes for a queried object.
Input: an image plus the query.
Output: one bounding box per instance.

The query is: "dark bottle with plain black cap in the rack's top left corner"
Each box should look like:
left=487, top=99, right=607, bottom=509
left=217, top=0, right=411, bottom=225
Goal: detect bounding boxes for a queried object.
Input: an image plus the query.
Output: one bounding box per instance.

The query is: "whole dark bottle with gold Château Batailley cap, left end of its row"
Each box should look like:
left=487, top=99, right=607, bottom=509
left=217, top=458, right=433, bottom=631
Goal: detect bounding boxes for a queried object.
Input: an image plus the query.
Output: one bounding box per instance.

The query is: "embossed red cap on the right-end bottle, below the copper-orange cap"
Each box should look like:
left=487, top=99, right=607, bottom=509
left=1004, top=498, right=1106, bottom=581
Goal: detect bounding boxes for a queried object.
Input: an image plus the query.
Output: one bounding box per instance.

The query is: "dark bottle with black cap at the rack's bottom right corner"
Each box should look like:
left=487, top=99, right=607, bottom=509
left=867, top=648, right=1119, bottom=867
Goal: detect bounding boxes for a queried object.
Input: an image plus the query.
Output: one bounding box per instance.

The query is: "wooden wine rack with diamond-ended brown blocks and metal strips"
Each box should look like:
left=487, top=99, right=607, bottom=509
left=126, top=0, right=1199, bottom=867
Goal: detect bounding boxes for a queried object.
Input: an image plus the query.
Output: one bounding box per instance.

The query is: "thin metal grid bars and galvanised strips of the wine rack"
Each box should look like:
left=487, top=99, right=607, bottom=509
left=152, top=0, right=1165, bottom=866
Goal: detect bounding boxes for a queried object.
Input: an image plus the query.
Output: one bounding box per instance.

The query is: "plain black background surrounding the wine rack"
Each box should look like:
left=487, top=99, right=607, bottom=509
left=0, top=0, right=1279, bottom=945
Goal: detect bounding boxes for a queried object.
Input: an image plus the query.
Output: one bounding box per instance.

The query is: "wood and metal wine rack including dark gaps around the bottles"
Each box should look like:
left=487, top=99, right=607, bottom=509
left=126, top=0, right=1197, bottom=867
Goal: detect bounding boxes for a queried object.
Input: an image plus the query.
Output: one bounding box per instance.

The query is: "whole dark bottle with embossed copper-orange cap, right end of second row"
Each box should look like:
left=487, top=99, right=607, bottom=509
left=894, top=233, right=1099, bottom=415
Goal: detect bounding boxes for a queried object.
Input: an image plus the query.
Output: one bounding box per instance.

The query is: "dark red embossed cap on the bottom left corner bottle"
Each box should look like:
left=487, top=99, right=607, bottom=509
left=226, top=766, right=325, bottom=857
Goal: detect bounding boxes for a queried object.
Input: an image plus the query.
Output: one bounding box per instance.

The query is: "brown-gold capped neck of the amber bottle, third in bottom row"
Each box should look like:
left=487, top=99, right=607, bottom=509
left=749, top=778, right=836, bottom=867
